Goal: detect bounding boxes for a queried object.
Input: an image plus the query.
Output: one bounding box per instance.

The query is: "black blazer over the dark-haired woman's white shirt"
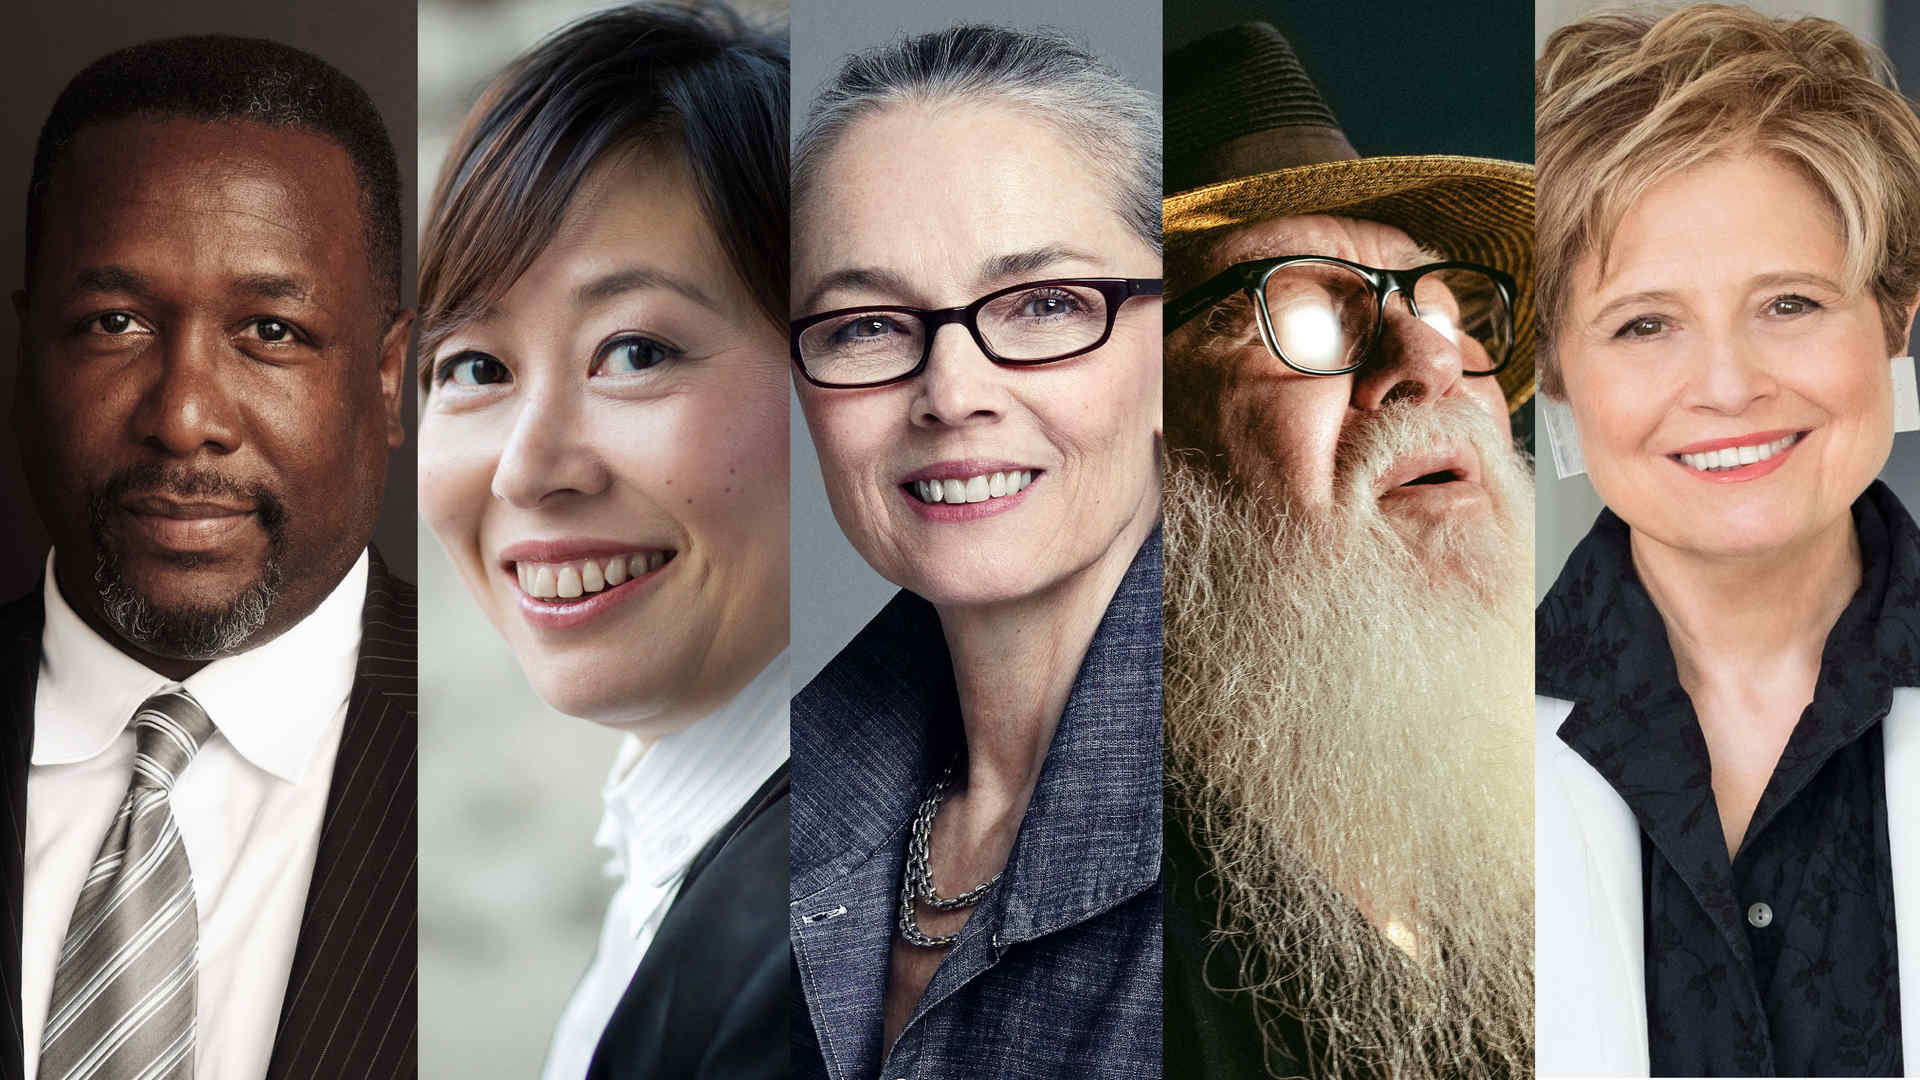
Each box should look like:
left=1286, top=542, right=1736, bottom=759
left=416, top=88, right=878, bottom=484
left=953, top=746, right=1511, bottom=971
left=588, top=765, right=791, bottom=1080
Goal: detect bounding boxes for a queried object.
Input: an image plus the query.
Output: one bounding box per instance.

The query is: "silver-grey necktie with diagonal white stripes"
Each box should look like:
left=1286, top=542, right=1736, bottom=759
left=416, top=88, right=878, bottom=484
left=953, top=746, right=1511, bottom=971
left=40, top=690, right=213, bottom=1080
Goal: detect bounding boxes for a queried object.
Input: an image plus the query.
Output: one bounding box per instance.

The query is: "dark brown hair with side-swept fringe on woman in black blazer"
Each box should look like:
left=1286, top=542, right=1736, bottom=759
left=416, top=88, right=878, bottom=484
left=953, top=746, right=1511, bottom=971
left=420, top=4, right=791, bottom=374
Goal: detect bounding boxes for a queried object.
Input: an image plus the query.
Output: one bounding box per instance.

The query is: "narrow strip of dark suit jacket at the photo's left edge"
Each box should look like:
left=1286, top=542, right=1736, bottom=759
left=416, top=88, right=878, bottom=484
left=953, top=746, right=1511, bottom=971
left=0, top=590, right=46, bottom=1080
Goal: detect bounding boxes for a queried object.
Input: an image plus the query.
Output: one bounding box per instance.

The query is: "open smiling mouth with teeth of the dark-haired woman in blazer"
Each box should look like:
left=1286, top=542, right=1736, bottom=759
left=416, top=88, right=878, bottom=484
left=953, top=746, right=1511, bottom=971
left=499, top=540, right=678, bottom=628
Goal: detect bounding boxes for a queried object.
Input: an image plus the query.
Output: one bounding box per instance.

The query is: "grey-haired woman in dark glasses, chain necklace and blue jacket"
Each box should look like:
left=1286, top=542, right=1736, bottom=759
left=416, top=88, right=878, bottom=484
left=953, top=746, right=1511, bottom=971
left=791, top=18, right=1162, bottom=1078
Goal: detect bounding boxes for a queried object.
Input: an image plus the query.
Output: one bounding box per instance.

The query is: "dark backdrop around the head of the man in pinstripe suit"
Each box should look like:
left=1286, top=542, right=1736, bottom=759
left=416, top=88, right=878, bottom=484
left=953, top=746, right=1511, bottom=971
left=0, top=0, right=415, bottom=600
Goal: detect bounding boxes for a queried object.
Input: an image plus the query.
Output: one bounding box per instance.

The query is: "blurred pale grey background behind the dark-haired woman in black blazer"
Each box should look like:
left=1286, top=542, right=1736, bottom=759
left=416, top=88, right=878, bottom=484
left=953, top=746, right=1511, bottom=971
left=409, top=0, right=787, bottom=1078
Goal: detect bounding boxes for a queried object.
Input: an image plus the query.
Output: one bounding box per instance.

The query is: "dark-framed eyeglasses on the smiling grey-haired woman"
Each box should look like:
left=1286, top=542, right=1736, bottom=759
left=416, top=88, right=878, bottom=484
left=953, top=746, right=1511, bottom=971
left=789, top=277, right=1160, bottom=390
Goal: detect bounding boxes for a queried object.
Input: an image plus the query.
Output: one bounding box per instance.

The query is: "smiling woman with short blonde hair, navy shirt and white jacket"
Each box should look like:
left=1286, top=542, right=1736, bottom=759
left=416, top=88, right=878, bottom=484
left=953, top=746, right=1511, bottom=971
left=1536, top=4, right=1920, bottom=1076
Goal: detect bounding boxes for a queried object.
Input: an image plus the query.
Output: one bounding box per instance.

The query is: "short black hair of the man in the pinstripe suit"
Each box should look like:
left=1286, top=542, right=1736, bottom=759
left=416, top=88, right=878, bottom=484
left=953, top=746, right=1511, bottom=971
left=27, top=35, right=401, bottom=317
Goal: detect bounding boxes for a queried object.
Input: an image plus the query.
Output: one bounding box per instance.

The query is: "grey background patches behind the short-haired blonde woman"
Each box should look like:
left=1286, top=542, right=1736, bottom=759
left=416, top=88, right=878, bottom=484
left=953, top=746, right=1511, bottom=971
left=1534, top=0, right=1920, bottom=600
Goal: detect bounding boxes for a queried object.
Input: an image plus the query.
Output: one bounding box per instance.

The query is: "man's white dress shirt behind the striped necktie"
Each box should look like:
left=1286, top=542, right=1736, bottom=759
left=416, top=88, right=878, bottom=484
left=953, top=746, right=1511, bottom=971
left=21, top=552, right=367, bottom=1080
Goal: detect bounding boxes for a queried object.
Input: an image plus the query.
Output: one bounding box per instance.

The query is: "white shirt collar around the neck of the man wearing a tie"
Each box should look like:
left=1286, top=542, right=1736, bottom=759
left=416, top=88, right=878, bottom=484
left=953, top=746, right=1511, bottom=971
left=33, top=552, right=367, bottom=782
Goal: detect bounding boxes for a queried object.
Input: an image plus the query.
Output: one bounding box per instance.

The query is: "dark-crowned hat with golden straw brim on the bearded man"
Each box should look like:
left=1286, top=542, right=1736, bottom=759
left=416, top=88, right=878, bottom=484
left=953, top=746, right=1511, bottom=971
left=1162, top=23, right=1534, bottom=411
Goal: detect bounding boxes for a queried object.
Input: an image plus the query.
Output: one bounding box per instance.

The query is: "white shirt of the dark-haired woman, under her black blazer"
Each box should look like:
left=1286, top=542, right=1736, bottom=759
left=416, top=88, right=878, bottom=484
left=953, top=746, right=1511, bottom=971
left=541, top=651, right=791, bottom=1080
